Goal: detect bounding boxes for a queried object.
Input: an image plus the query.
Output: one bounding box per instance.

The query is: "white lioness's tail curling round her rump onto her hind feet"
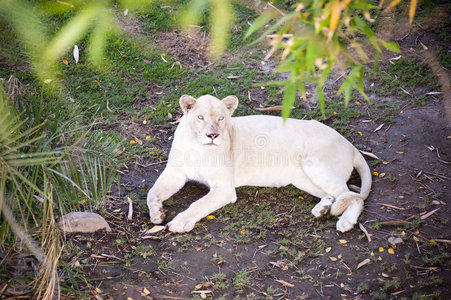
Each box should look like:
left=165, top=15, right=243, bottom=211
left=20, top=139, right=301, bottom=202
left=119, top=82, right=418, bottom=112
left=330, top=149, right=372, bottom=216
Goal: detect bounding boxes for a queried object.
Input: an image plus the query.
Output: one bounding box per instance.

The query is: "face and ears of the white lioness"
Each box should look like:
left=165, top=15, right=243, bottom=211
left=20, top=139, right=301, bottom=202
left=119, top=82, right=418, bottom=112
left=180, top=95, right=238, bottom=146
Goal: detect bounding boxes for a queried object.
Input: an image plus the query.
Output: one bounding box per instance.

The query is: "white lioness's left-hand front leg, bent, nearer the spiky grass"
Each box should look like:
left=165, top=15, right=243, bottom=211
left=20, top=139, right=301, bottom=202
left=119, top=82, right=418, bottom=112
left=147, top=167, right=186, bottom=224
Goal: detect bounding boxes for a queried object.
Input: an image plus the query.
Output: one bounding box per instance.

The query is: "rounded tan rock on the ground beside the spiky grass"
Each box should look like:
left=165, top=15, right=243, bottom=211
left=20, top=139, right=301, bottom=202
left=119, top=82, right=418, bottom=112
left=58, top=212, right=111, bottom=233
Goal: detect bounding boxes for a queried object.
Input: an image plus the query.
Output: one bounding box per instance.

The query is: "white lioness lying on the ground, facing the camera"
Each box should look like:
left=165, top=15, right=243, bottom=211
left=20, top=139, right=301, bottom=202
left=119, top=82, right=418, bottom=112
left=147, top=95, right=371, bottom=232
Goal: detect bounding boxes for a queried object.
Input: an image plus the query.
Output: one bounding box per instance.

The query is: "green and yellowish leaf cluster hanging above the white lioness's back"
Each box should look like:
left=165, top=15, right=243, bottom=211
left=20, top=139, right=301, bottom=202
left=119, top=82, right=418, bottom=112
left=247, top=0, right=400, bottom=118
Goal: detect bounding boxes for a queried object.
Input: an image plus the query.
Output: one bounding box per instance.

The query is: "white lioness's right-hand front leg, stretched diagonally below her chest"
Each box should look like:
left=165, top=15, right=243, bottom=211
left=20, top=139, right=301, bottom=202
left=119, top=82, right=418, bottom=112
left=168, top=188, right=236, bottom=232
